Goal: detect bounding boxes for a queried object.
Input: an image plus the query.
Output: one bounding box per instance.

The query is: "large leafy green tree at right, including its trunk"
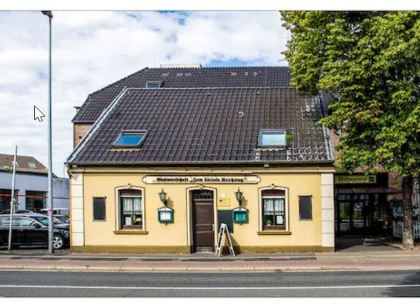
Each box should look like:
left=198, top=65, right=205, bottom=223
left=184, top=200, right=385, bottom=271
left=281, top=11, right=420, bottom=248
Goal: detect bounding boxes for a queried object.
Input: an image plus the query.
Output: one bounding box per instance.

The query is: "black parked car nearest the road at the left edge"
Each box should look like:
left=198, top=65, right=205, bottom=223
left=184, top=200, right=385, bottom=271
left=0, top=214, right=70, bottom=249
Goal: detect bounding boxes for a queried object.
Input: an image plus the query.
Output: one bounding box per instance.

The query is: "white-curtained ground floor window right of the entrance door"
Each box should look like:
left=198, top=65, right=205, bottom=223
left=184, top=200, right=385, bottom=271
left=261, top=189, right=286, bottom=230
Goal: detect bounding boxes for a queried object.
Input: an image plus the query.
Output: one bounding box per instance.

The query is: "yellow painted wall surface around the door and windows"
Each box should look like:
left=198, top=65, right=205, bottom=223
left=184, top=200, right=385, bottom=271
left=76, top=169, right=332, bottom=251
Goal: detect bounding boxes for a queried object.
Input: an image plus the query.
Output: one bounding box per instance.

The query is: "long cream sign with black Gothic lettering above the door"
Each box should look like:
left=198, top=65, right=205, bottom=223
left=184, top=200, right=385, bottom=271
left=143, top=175, right=260, bottom=184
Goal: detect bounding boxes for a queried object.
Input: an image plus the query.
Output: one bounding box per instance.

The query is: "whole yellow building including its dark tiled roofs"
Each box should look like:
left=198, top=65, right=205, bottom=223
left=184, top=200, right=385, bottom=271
left=67, top=67, right=334, bottom=253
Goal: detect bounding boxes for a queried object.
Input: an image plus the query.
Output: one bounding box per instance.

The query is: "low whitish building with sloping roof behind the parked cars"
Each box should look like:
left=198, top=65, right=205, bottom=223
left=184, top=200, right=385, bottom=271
left=0, top=154, right=69, bottom=212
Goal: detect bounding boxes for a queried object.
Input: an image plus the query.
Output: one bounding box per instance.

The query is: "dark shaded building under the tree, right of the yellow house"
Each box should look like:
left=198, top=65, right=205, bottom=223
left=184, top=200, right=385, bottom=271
left=330, top=132, right=420, bottom=237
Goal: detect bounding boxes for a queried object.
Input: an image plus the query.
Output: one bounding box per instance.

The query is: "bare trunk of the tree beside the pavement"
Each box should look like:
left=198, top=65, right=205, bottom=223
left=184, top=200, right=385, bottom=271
left=402, top=175, right=414, bottom=249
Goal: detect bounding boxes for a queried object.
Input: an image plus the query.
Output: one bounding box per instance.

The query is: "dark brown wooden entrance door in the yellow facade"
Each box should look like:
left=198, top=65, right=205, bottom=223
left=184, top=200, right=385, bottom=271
left=191, top=190, right=214, bottom=252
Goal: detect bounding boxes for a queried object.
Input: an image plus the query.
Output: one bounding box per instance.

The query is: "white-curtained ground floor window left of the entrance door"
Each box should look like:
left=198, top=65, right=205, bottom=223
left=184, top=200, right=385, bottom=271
left=119, top=189, right=144, bottom=229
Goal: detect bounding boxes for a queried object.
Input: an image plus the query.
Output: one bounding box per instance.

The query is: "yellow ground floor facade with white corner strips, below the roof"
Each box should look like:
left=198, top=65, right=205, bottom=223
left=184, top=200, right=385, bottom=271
left=71, top=167, right=334, bottom=253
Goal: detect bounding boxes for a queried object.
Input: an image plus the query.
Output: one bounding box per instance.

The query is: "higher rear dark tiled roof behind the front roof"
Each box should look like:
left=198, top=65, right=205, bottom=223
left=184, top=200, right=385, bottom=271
left=73, top=67, right=290, bottom=123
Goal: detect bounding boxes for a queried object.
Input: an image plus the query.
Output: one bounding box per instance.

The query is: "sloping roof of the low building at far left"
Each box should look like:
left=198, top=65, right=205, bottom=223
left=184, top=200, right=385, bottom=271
left=0, top=154, right=48, bottom=174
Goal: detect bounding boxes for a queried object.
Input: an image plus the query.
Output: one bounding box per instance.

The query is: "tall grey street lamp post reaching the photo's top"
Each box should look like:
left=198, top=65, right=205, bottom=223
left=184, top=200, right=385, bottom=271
left=41, top=11, right=54, bottom=254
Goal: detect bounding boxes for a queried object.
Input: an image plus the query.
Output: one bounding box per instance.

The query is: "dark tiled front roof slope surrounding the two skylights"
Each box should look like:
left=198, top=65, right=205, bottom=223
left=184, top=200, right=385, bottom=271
left=69, top=88, right=331, bottom=165
